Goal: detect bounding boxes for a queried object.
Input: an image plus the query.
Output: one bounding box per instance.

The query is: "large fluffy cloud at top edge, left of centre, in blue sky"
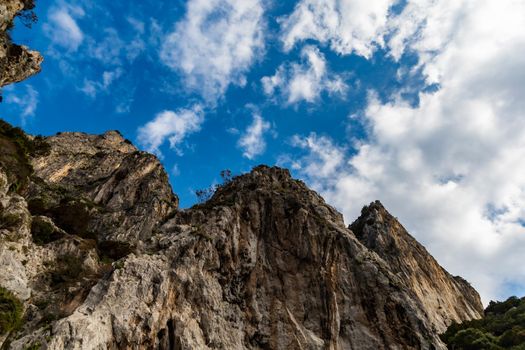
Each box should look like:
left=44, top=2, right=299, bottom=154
left=161, top=0, right=264, bottom=102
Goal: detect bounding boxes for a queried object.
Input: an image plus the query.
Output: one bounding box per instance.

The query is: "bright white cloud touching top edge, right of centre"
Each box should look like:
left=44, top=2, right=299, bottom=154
left=281, top=0, right=397, bottom=57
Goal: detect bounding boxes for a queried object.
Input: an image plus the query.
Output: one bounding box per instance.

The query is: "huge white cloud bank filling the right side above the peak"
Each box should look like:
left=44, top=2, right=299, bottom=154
left=286, top=0, right=525, bottom=302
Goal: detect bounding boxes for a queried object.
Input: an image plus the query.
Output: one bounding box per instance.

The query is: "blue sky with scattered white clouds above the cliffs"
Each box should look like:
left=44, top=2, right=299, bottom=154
left=0, top=0, right=525, bottom=303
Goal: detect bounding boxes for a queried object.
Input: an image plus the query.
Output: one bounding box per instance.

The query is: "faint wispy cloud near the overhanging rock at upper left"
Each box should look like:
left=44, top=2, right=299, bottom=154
left=43, top=5, right=84, bottom=52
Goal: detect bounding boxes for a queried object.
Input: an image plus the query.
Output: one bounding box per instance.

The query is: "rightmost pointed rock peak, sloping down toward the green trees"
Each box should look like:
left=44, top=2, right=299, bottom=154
left=349, top=201, right=483, bottom=332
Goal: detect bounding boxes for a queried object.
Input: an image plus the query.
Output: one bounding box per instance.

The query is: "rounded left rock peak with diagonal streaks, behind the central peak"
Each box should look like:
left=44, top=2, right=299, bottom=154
left=30, top=131, right=178, bottom=244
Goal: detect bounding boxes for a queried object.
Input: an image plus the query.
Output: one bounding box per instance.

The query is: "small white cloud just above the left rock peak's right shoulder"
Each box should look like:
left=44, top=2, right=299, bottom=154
left=138, top=105, right=204, bottom=157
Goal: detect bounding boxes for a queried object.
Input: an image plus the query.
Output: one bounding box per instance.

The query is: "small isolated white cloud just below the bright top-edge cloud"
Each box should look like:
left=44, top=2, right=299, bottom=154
left=261, top=45, right=347, bottom=104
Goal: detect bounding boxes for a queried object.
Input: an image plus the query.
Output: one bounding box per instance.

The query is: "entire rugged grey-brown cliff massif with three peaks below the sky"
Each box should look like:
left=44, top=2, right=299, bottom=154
left=0, top=125, right=482, bottom=349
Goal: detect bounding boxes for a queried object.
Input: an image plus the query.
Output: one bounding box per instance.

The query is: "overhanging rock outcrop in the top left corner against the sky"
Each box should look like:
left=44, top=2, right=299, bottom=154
left=0, top=0, right=43, bottom=88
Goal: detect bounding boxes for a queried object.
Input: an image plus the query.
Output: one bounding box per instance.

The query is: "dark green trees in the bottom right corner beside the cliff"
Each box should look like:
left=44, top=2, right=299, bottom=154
left=441, top=297, right=525, bottom=350
